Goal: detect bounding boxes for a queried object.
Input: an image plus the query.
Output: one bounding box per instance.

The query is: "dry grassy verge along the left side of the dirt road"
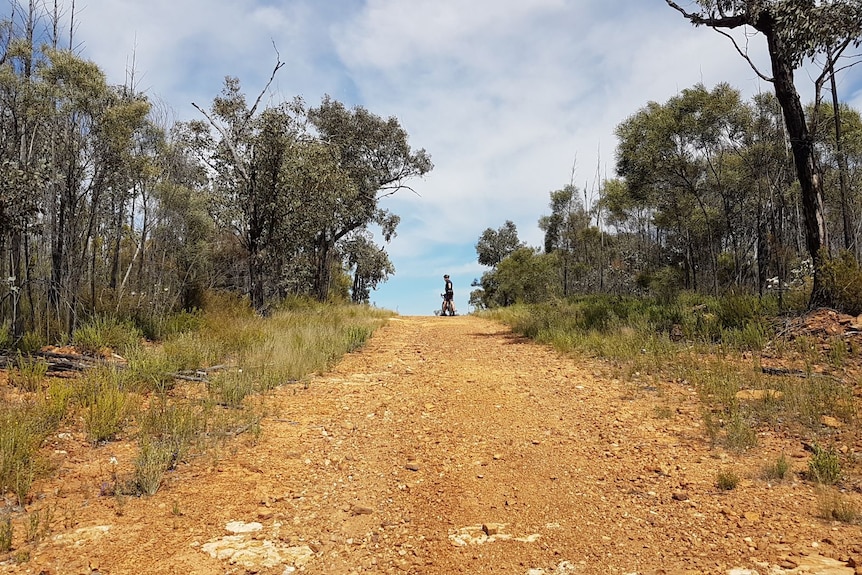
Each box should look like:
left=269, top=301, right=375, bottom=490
left=0, top=296, right=390, bottom=509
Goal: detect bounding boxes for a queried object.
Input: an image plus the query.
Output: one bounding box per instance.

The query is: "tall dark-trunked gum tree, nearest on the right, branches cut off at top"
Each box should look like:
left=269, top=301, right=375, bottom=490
left=665, top=0, right=862, bottom=307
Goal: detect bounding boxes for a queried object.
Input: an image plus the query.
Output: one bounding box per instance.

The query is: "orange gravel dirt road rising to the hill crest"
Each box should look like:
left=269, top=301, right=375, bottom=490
left=6, top=317, right=862, bottom=575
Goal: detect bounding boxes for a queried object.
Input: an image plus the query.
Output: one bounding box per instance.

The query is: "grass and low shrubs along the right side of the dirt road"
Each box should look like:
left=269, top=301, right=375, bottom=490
left=480, top=293, right=862, bottom=522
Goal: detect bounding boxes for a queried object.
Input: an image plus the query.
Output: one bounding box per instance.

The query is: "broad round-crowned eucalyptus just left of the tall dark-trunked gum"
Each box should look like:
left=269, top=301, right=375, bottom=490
left=616, top=84, right=750, bottom=291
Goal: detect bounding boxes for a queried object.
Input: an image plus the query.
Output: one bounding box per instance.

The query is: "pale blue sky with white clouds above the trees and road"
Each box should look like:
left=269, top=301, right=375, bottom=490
left=59, top=0, right=862, bottom=315
